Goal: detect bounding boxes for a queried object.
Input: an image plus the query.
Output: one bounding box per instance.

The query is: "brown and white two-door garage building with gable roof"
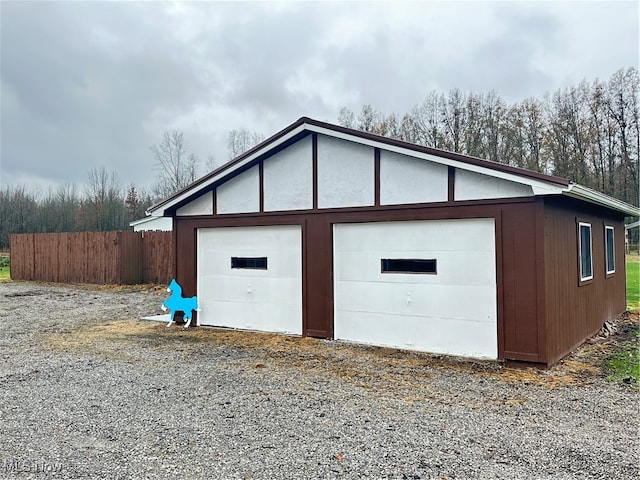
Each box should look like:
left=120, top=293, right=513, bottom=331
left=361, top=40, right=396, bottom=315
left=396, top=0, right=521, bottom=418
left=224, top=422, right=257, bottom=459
left=148, top=117, right=640, bottom=365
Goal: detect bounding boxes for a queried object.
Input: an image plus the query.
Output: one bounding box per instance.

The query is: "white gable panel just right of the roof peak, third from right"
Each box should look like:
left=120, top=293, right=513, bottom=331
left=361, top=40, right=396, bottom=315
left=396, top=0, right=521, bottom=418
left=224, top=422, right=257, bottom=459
left=318, top=135, right=375, bottom=208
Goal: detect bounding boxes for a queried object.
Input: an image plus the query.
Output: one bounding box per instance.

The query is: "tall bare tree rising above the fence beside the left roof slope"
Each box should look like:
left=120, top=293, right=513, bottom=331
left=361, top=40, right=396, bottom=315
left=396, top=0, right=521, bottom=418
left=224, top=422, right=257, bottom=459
left=151, top=130, right=198, bottom=198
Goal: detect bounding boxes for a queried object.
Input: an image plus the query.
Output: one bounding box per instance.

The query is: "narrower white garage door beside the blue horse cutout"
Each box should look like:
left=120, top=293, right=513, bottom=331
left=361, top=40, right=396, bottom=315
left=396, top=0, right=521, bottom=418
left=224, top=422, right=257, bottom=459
left=198, top=225, right=302, bottom=335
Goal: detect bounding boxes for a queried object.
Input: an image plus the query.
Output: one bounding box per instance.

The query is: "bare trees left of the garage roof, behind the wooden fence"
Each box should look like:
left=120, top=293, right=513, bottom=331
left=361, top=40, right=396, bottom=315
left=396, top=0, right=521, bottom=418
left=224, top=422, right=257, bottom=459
left=0, top=129, right=263, bottom=250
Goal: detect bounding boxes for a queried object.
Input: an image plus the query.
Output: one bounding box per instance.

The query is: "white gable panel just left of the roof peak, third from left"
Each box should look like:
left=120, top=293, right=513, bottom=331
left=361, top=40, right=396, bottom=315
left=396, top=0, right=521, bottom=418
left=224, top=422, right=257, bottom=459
left=263, top=135, right=313, bottom=212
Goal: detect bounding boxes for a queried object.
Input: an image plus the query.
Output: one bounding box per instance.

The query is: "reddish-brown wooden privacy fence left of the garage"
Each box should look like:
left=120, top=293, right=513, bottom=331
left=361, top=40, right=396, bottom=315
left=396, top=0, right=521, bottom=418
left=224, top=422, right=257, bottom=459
left=9, top=231, right=174, bottom=285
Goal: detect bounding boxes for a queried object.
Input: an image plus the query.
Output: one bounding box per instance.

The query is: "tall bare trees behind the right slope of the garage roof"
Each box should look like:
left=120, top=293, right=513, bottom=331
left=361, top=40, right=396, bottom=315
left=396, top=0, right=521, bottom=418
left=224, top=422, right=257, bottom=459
left=338, top=68, right=640, bottom=210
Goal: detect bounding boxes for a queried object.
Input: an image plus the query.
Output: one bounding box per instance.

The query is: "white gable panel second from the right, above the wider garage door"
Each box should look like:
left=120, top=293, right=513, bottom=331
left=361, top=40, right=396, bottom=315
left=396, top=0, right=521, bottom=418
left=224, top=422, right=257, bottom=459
left=380, top=150, right=449, bottom=205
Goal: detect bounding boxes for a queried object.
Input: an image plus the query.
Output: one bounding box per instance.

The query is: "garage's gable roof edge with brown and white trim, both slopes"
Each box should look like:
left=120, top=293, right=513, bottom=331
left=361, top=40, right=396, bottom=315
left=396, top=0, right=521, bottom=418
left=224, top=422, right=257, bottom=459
left=147, top=117, right=640, bottom=217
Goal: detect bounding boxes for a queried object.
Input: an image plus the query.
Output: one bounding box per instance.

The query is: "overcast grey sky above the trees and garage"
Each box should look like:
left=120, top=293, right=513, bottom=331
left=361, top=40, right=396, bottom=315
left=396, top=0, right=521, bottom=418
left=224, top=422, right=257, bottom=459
left=0, top=1, right=639, bottom=193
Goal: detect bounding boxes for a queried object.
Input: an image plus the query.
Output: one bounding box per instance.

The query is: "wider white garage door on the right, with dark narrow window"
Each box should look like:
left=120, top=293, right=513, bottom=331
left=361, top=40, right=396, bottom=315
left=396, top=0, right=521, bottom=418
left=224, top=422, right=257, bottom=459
left=334, top=218, right=498, bottom=358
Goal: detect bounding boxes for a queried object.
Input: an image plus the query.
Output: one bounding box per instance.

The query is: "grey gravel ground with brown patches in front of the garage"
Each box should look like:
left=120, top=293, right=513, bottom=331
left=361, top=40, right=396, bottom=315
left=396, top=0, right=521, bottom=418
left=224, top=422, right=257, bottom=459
left=0, top=283, right=640, bottom=479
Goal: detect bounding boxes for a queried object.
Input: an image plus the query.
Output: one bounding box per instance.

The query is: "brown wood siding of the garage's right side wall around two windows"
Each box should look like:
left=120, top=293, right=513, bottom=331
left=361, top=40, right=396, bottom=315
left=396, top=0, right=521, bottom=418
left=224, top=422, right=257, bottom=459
left=542, top=198, right=626, bottom=364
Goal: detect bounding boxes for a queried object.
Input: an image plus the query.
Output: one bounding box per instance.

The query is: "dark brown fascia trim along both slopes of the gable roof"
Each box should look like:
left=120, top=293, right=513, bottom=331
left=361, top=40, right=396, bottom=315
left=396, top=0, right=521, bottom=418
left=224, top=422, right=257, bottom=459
left=148, top=117, right=570, bottom=212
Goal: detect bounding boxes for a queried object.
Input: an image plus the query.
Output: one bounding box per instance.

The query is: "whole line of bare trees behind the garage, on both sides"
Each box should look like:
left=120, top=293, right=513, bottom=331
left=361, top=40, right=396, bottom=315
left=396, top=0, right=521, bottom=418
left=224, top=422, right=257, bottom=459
left=0, top=68, right=640, bottom=249
